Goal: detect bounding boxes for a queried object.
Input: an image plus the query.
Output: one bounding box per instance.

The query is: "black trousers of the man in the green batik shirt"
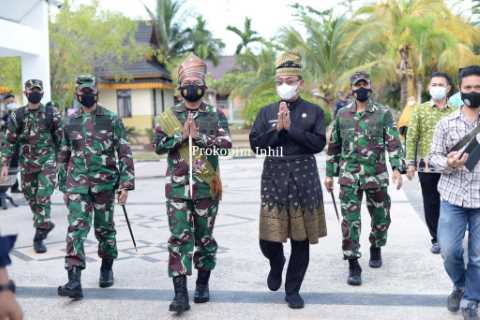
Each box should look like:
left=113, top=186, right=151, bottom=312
left=418, top=172, right=441, bottom=243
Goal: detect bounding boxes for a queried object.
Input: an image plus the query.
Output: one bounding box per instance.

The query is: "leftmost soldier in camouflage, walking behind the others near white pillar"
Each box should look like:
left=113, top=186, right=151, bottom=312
left=1, top=79, right=63, bottom=253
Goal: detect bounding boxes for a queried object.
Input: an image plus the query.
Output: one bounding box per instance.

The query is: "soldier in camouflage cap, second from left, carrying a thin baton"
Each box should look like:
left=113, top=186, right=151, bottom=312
left=58, top=75, right=134, bottom=298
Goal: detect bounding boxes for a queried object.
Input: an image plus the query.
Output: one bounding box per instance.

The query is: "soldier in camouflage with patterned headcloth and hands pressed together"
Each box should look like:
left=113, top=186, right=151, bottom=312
left=155, top=55, right=232, bottom=313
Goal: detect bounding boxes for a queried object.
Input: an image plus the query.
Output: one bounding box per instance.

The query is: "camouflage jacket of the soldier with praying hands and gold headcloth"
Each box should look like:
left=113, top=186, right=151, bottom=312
left=155, top=103, right=232, bottom=199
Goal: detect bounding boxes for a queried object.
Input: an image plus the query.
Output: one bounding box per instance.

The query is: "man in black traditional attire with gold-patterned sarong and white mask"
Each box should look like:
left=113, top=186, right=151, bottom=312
left=250, top=52, right=327, bottom=309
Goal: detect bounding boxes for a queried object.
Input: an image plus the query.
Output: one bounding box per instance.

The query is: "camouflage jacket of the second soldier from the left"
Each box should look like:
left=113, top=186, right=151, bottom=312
left=59, top=105, right=135, bottom=194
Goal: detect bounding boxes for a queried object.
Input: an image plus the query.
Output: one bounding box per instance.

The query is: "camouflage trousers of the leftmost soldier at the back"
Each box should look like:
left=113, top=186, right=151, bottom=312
left=21, top=167, right=57, bottom=230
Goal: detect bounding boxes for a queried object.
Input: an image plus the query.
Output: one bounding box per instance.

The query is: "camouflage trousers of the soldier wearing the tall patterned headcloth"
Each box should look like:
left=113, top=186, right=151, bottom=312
left=167, top=198, right=218, bottom=277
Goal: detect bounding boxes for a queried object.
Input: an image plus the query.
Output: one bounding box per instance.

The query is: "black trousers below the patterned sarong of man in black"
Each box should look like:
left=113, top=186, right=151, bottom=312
left=260, top=239, right=310, bottom=294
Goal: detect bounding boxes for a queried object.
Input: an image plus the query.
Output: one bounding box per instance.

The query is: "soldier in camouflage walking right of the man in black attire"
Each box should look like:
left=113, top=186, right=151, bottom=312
left=325, top=72, right=403, bottom=285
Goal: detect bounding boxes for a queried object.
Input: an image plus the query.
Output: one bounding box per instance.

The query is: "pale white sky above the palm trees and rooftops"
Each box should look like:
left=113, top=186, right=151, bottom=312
left=74, top=0, right=352, bottom=55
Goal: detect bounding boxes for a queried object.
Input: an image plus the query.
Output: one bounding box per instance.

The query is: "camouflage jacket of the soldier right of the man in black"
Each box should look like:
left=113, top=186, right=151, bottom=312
left=326, top=101, right=403, bottom=189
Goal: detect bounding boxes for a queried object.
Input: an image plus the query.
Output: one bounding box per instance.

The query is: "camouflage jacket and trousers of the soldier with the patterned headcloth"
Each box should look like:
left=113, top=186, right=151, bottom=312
left=155, top=103, right=232, bottom=277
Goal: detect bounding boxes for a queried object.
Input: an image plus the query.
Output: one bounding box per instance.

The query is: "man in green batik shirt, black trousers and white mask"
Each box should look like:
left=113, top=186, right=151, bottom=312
left=406, top=72, right=457, bottom=254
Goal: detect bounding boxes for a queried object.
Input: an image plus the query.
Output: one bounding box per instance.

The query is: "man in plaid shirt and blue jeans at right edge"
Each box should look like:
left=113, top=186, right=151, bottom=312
left=430, top=66, right=480, bottom=320
